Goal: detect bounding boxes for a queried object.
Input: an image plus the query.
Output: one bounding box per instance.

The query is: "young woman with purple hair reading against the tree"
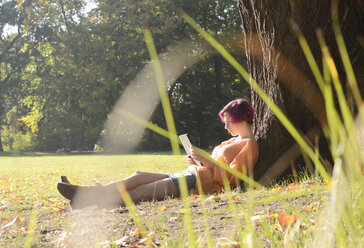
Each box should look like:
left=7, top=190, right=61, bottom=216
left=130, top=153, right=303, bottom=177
left=57, top=99, right=259, bottom=209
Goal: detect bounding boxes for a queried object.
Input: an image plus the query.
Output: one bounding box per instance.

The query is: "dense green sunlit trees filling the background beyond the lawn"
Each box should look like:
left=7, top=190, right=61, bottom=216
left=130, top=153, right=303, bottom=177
left=0, top=0, right=249, bottom=151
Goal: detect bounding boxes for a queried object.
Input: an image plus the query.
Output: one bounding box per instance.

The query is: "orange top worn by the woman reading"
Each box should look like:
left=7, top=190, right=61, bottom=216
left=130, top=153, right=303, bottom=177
left=193, top=137, right=259, bottom=194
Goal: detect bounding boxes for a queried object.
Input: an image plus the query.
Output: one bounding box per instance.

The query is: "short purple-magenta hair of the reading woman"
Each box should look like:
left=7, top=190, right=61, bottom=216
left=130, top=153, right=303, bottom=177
left=219, top=98, right=254, bottom=125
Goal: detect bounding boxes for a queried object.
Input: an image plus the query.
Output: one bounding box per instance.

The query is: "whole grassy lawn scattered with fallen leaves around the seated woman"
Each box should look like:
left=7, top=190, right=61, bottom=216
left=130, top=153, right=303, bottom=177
left=0, top=153, right=364, bottom=247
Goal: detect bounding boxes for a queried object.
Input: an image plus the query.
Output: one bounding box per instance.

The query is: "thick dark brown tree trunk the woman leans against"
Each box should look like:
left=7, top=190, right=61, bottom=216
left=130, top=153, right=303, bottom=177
left=238, top=0, right=364, bottom=184
